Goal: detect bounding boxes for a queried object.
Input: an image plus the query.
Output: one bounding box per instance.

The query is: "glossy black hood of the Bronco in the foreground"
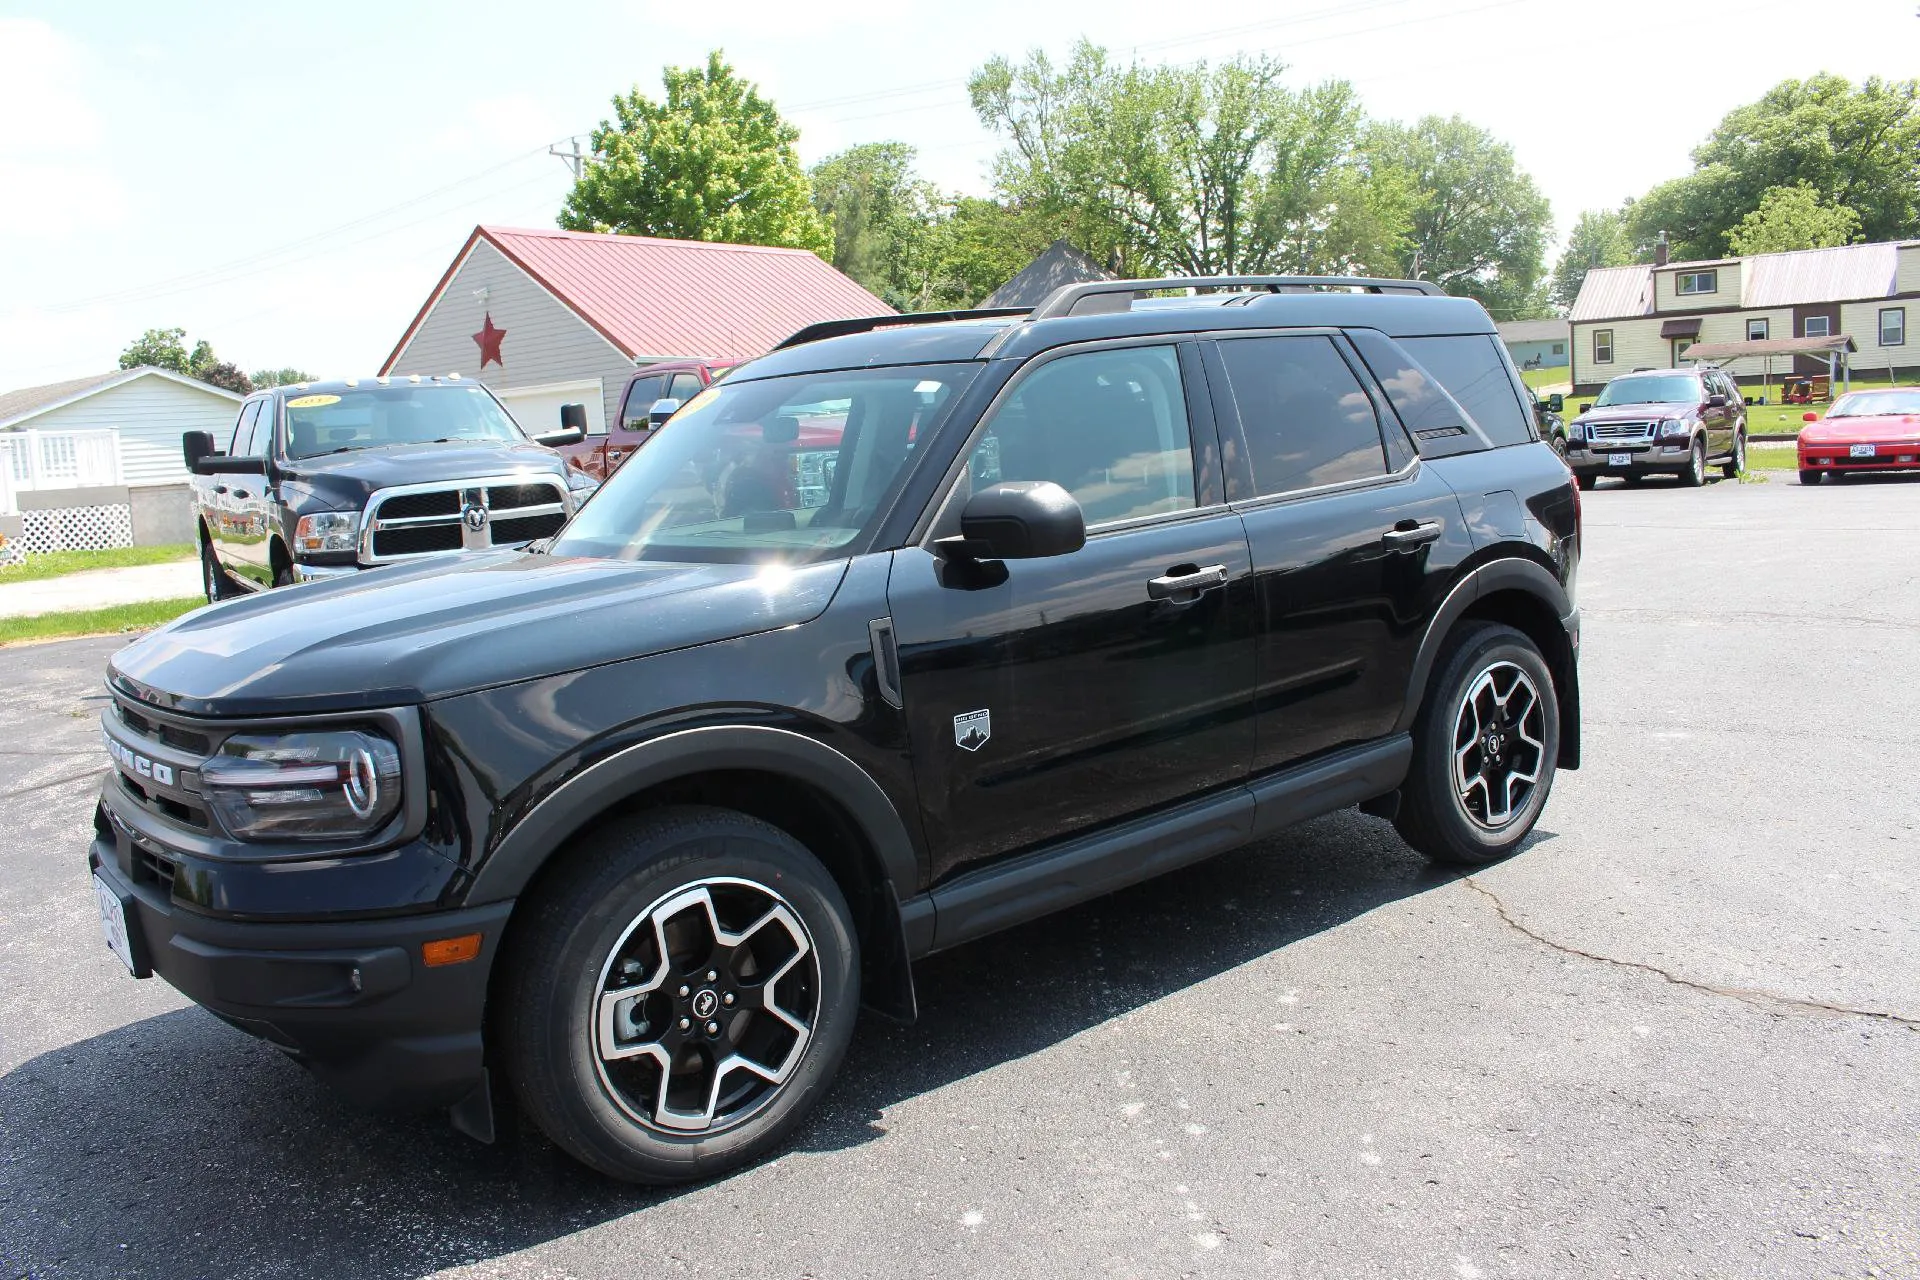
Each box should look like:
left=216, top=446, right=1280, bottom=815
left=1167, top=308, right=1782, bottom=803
left=108, top=551, right=847, bottom=716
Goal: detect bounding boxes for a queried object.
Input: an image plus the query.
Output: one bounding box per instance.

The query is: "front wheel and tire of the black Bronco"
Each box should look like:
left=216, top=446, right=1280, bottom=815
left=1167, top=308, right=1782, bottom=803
left=493, top=806, right=860, bottom=1184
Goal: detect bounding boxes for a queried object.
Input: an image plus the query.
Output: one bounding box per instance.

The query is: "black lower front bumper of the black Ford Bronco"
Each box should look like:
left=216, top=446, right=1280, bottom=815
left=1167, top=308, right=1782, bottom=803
left=86, top=823, right=513, bottom=1109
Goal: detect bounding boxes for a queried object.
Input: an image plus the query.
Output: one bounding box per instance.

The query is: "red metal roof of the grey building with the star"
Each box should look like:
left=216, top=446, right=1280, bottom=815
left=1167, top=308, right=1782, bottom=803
left=380, top=226, right=893, bottom=372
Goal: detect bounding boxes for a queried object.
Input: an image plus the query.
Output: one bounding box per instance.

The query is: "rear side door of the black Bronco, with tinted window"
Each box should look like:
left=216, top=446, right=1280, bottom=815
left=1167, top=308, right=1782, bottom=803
left=1208, top=332, right=1473, bottom=773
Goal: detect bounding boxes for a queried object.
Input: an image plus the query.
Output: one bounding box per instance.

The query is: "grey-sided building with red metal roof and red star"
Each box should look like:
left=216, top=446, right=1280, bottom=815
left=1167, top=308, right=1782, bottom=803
left=380, top=226, right=893, bottom=432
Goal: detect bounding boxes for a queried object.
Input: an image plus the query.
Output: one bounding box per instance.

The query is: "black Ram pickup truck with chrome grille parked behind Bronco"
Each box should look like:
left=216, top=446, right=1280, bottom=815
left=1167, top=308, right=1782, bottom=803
left=180, top=376, right=599, bottom=601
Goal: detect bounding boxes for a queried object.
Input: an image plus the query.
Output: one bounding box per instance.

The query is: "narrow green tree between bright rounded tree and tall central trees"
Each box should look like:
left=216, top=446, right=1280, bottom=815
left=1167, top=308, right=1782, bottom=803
left=808, top=142, right=950, bottom=311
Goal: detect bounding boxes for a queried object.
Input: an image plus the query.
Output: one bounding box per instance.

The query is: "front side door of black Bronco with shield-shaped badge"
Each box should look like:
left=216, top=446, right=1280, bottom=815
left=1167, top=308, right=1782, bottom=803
left=887, top=345, right=1254, bottom=879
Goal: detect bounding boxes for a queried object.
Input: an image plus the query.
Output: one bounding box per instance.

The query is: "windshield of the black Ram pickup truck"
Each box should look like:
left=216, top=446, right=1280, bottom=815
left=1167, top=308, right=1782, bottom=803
left=286, top=384, right=526, bottom=459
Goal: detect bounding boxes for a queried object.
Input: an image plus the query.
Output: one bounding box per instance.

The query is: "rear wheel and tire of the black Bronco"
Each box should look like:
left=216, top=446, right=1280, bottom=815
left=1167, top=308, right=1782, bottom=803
left=1394, top=622, right=1559, bottom=867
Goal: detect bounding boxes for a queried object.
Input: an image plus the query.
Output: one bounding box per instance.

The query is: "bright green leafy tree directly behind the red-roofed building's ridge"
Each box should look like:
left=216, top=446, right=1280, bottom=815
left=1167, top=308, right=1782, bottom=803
left=559, top=50, right=833, bottom=257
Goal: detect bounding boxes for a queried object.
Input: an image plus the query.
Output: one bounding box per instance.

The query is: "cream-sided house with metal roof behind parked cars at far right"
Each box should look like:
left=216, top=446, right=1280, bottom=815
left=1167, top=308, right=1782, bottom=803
left=1567, top=240, right=1920, bottom=395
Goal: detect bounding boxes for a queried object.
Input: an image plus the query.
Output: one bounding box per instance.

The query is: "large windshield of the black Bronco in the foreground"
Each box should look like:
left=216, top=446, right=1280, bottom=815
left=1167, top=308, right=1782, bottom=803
left=553, top=365, right=979, bottom=562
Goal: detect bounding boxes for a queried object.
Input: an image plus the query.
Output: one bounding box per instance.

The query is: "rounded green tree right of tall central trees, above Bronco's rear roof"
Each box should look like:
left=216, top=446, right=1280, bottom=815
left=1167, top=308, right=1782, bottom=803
left=1365, top=115, right=1553, bottom=320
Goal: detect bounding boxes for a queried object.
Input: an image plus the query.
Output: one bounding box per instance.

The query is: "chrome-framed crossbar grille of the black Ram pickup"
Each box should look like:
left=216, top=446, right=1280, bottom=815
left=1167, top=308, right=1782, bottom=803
left=361, top=476, right=568, bottom=564
